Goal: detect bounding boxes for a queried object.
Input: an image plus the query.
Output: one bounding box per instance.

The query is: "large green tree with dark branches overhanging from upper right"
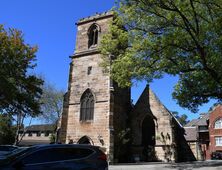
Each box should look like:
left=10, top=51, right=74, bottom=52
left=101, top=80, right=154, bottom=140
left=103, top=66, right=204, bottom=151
left=101, top=0, right=222, bottom=112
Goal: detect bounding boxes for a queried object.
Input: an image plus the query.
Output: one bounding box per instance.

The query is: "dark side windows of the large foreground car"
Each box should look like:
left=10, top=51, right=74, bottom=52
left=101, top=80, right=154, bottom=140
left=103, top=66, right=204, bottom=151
left=23, top=148, right=94, bottom=164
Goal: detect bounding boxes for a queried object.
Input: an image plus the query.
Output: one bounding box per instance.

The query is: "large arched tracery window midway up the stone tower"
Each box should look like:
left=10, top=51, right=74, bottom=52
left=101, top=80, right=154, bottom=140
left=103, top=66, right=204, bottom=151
left=80, top=89, right=94, bottom=121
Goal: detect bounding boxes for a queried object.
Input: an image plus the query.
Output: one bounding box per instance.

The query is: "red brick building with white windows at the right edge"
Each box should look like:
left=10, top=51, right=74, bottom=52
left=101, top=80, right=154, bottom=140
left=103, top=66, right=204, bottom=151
left=209, top=105, right=222, bottom=158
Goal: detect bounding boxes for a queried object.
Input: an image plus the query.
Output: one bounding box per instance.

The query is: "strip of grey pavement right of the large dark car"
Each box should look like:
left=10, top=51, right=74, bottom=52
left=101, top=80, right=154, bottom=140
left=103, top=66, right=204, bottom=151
left=109, top=160, right=222, bottom=170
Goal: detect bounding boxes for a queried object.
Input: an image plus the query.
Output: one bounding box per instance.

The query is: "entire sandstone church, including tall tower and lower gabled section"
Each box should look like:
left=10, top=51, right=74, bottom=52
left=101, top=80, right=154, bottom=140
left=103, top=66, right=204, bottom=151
left=60, top=12, right=195, bottom=161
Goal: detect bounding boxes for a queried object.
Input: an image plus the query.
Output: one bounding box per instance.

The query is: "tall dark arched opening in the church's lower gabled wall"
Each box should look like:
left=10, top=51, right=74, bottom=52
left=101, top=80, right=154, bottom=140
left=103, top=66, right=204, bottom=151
left=142, top=116, right=156, bottom=161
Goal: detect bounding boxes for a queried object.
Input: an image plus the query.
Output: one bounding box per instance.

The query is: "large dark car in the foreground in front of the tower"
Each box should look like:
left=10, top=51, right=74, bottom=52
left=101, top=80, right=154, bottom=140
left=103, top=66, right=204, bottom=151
left=0, top=144, right=108, bottom=170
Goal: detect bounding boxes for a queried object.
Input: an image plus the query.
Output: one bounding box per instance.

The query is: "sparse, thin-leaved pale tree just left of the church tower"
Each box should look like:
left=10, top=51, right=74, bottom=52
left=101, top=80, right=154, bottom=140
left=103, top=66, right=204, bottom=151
left=39, top=81, right=65, bottom=140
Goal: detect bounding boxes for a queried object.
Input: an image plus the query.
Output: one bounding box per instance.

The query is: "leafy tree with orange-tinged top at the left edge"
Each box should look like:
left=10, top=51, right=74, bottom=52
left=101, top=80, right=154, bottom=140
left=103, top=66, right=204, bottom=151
left=0, top=25, right=43, bottom=144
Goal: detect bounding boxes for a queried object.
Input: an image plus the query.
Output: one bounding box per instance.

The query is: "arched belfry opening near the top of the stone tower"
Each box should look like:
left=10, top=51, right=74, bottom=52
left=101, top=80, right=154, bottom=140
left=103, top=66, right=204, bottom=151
left=88, top=24, right=99, bottom=48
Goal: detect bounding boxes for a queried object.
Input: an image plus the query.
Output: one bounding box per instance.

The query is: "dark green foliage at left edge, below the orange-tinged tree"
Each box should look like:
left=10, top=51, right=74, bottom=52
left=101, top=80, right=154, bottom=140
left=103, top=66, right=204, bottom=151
left=0, top=114, right=16, bottom=145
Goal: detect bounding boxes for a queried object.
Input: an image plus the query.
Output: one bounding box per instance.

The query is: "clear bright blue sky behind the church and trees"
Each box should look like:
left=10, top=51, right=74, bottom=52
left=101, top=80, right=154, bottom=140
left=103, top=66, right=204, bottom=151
left=0, top=0, right=215, bottom=119
